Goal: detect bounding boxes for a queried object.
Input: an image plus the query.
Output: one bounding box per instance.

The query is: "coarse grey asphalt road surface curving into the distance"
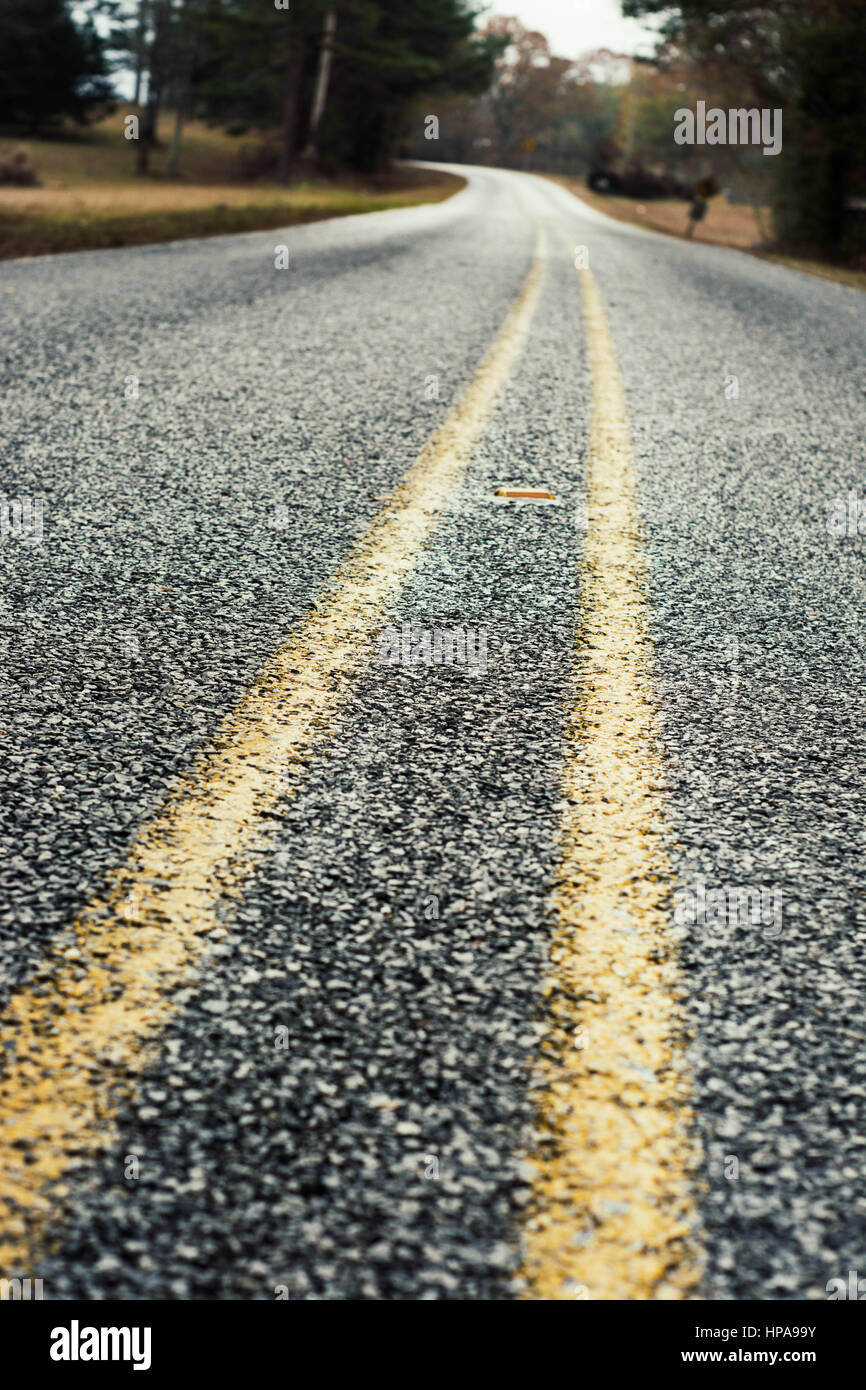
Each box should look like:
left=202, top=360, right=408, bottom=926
left=0, top=170, right=866, bottom=1300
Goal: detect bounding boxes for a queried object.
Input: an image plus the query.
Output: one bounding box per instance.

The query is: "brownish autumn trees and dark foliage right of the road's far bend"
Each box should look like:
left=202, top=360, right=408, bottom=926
left=405, top=0, right=866, bottom=264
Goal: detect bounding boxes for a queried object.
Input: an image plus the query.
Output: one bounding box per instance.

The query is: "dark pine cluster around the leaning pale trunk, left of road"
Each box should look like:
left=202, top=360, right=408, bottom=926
left=109, top=0, right=495, bottom=178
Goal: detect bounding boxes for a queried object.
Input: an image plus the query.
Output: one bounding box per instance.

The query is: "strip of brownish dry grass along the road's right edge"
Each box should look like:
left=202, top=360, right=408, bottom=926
left=550, top=175, right=866, bottom=289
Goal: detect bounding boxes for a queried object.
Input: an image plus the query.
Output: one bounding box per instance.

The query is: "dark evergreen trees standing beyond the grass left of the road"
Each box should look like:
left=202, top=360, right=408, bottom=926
left=0, top=0, right=498, bottom=181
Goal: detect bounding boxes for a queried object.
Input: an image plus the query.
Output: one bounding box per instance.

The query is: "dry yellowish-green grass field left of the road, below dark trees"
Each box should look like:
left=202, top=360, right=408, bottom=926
left=0, top=111, right=461, bottom=259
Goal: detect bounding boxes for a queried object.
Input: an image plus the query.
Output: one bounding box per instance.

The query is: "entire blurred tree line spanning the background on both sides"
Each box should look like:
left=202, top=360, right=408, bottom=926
left=0, top=0, right=866, bottom=257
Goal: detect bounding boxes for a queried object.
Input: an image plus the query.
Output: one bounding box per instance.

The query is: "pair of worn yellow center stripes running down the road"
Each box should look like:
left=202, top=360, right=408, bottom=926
left=0, top=222, right=706, bottom=1298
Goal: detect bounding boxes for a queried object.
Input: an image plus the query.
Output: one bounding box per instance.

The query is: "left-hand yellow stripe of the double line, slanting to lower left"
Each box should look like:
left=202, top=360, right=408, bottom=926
left=0, top=230, right=544, bottom=1276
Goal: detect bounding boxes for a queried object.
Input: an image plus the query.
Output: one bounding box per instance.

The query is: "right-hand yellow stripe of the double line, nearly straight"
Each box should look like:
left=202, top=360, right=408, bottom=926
left=521, top=261, right=701, bottom=1300
